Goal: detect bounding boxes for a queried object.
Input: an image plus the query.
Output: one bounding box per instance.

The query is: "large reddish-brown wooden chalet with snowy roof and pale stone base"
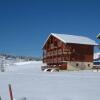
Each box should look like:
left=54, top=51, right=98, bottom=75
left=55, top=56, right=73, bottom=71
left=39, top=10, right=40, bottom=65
left=43, top=33, right=97, bottom=70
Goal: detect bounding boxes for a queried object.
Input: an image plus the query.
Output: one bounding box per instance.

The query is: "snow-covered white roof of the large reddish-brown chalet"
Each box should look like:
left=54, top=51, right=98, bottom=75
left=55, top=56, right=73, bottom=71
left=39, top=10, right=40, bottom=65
left=45, top=33, right=98, bottom=45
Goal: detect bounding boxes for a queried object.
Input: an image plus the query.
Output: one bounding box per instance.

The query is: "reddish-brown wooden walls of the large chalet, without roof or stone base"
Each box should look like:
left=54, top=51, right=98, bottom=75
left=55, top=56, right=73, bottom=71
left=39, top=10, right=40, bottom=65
left=43, top=35, right=93, bottom=70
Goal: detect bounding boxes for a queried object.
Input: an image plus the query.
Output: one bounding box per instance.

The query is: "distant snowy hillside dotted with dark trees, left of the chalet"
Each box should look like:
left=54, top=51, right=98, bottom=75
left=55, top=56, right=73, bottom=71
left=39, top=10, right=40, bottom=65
left=0, top=53, right=41, bottom=66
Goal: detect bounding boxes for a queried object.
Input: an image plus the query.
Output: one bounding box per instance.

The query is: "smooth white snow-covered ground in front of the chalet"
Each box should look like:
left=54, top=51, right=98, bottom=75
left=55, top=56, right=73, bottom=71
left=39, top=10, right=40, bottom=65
left=0, top=62, right=100, bottom=100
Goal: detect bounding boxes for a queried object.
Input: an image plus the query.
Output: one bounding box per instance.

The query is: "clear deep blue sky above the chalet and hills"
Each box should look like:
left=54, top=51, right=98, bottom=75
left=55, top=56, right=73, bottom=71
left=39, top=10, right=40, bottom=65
left=0, top=0, right=100, bottom=56
